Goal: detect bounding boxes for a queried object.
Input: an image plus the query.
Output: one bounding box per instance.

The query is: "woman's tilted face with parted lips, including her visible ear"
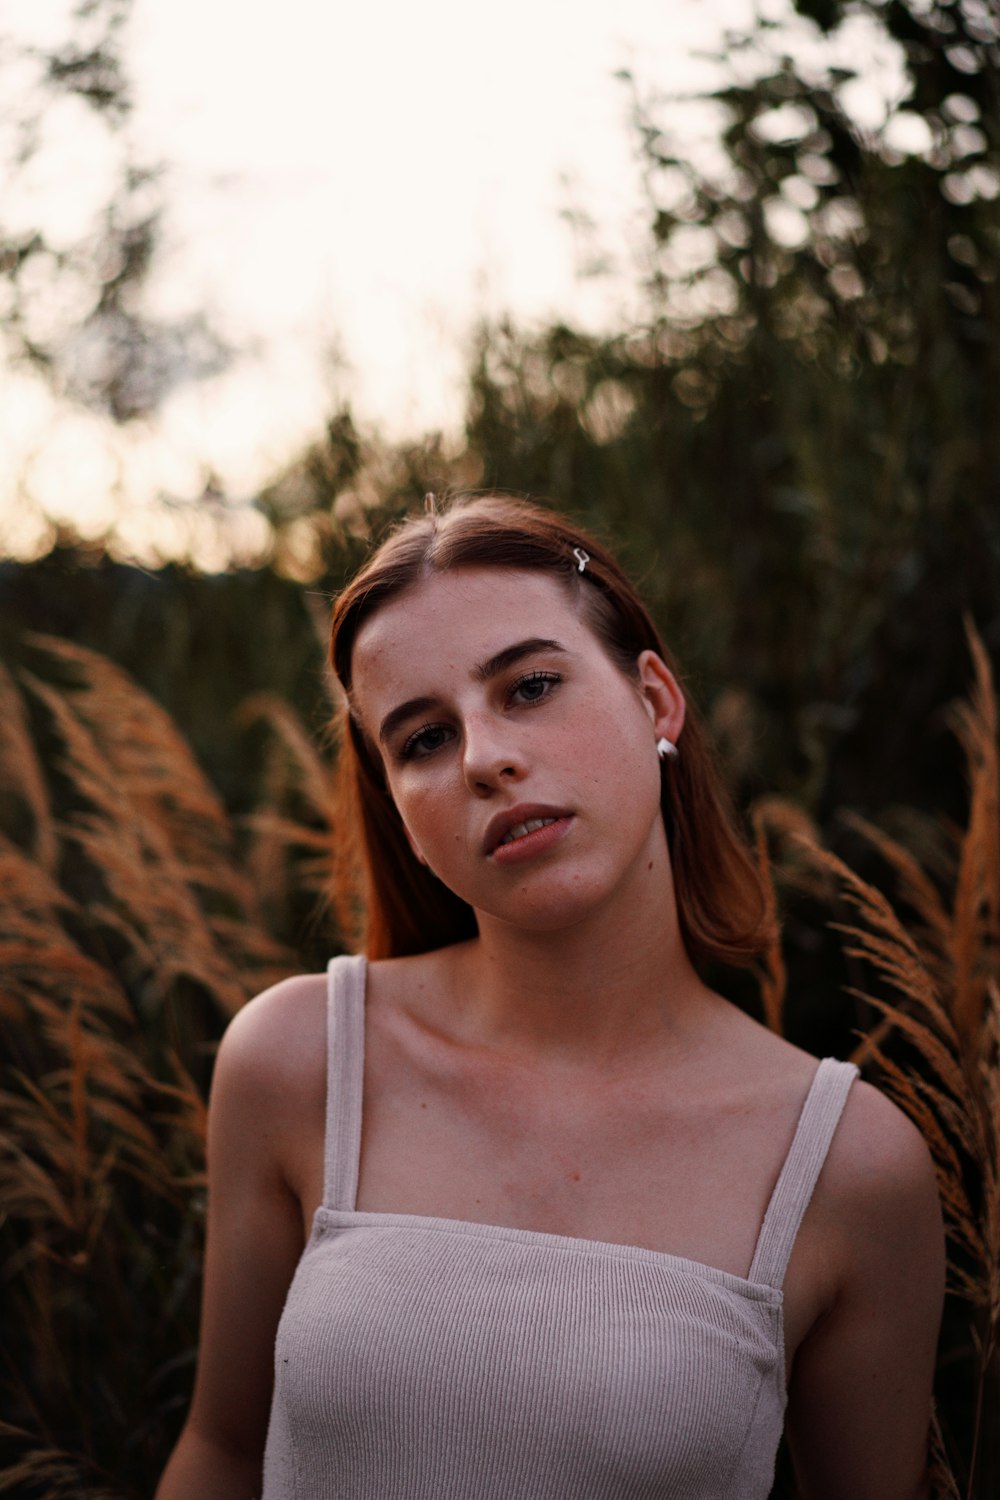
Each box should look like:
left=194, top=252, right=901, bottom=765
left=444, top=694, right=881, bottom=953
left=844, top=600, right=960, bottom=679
left=352, top=567, right=684, bottom=930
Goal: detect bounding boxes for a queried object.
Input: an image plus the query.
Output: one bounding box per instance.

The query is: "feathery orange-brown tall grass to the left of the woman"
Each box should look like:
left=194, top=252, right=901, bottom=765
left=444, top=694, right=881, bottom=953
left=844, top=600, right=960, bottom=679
left=0, top=636, right=319, bottom=1500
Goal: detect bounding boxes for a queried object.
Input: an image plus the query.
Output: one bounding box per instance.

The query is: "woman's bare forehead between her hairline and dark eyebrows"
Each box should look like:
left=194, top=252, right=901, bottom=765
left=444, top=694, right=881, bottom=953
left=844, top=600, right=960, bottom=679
left=351, top=567, right=587, bottom=702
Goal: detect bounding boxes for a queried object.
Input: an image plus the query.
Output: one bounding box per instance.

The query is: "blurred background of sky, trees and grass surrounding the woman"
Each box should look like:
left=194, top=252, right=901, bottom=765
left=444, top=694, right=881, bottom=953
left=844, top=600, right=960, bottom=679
left=0, top=0, right=1000, bottom=1500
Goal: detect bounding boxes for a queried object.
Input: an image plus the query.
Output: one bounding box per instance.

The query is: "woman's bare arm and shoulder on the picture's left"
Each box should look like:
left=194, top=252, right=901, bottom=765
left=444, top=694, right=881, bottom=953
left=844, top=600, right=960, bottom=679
left=156, top=978, right=325, bottom=1500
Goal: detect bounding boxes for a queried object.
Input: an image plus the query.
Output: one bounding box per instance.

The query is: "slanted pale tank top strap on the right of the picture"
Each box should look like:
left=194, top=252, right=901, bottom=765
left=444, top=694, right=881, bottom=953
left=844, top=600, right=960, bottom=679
left=747, top=1058, right=858, bottom=1287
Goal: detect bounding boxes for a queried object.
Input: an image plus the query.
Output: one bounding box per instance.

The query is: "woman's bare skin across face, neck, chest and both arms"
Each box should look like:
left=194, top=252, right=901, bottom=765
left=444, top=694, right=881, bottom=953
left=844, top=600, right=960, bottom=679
left=157, top=567, right=943, bottom=1500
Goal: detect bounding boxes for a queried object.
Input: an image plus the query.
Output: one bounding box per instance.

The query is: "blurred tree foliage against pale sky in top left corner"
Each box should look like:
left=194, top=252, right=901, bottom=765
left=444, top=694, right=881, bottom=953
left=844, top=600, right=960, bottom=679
left=0, top=0, right=228, bottom=422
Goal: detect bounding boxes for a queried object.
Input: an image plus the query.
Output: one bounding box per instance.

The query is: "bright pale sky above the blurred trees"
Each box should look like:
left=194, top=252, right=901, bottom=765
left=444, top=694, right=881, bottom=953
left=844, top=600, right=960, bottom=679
left=0, top=0, right=905, bottom=566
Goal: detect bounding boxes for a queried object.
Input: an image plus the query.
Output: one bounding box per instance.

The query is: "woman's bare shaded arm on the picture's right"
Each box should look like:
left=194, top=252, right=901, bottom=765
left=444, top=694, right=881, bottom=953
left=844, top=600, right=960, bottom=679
left=787, top=1083, right=945, bottom=1500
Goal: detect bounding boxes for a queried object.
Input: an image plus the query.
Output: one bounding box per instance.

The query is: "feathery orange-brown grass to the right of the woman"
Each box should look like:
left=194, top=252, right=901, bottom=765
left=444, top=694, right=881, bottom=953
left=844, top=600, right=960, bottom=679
left=757, top=629, right=1000, bottom=1500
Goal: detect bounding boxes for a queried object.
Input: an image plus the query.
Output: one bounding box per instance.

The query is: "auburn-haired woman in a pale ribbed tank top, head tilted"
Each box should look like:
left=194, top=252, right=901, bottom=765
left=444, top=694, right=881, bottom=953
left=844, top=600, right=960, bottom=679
left=159, top=497, right=943, bottom=1500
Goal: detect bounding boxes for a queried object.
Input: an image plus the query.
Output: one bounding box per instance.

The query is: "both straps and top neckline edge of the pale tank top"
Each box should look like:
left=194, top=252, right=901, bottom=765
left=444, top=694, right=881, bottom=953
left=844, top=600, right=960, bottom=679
left=313, top=954, right=858, bottom=1307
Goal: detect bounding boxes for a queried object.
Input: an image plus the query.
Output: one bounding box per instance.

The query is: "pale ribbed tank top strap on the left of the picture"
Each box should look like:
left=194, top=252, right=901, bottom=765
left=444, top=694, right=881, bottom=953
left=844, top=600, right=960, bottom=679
left=322, top=954, right=367, bottom=1211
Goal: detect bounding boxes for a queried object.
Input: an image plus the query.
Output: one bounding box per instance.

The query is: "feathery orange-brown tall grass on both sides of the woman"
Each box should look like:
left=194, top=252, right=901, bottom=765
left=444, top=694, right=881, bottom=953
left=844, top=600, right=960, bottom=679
left=0, top=636, right=1000, bottom=1500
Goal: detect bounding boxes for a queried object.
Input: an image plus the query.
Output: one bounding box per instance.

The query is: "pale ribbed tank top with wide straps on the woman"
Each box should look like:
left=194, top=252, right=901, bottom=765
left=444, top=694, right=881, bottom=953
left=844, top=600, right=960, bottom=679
left=262, top=957, right=858, bottom=1500
